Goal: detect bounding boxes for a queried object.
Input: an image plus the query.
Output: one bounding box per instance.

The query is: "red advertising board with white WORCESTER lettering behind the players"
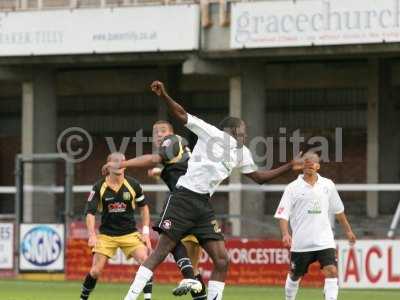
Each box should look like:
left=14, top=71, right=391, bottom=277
left=66, top=225, right=323, bottom=286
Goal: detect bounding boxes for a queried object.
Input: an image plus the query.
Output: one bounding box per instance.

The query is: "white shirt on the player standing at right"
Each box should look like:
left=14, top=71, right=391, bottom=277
left=275, top=174, right=344, bottom=252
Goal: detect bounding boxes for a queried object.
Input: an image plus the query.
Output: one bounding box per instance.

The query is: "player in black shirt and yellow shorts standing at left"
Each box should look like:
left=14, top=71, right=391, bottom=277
left=80, top=153, right=152, bottom=300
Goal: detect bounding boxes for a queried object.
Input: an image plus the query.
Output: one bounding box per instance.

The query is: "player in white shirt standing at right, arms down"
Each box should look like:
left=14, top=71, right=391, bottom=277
left=275, top=152, right=356, bottom=300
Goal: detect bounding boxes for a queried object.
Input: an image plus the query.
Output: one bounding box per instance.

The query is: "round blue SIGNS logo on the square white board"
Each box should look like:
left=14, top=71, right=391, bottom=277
left=21, top=226, right=62, bottom=267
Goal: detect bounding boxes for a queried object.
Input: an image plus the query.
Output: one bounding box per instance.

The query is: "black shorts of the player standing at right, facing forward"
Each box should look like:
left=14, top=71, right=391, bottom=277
left=290, top=248, right=337, bottom=277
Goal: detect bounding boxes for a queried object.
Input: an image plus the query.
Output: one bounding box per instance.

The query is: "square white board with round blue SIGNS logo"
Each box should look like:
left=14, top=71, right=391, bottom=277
left=19, top=224, right=65, bottom=271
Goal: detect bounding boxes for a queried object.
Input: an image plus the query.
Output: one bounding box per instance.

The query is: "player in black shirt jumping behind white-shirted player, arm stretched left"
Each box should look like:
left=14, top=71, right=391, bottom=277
left=102, top=120, right=207, bottom=300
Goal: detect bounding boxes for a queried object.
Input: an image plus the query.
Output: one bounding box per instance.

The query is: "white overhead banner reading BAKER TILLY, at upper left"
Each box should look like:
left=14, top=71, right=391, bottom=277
left=0, top=5, right=200, bottom=56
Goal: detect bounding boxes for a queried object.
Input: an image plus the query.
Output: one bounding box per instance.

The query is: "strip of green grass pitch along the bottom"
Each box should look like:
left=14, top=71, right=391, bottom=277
left=0, top=280, right=400, bottom=300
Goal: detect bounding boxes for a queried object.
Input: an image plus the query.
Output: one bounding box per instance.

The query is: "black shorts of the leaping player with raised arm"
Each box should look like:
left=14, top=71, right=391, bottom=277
left=153, top=187, right=224, bottom=244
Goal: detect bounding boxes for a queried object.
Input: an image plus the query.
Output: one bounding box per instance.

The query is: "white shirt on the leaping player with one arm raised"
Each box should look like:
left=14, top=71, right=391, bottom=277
left=177, top=114, right=257, bottom=195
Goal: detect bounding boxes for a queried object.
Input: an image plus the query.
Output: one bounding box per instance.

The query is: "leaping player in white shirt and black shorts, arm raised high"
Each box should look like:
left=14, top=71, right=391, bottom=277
left=125, top=81, right=299, bottom=300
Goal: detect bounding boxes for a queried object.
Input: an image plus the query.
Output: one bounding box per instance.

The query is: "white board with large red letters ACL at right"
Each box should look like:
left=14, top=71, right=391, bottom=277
left=338, top=240, right=400, bottom=289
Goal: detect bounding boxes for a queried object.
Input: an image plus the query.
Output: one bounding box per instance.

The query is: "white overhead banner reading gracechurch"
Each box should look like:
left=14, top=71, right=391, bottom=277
left=231, top=0, right=400, bottom=49
